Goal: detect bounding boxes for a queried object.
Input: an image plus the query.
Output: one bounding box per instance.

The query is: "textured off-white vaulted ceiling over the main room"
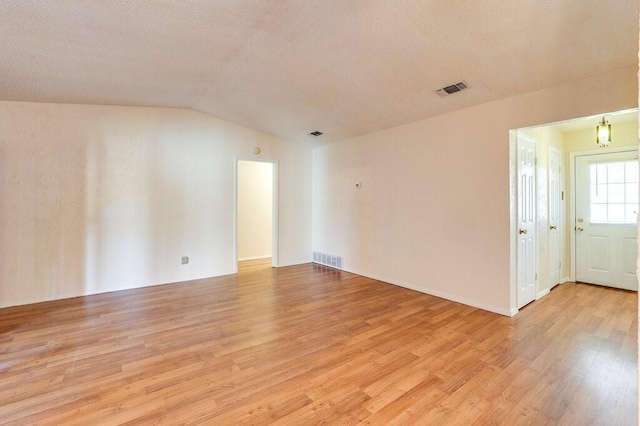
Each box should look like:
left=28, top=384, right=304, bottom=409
left=0, top=0, right=638, bottom=144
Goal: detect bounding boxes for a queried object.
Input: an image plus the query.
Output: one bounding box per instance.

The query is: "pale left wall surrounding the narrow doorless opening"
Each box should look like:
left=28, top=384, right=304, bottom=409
left=0, top=102, right=311, bottom=306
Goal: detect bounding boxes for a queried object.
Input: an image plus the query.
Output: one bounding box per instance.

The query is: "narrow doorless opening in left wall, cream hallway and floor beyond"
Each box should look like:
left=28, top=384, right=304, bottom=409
left=235, top=159, right=278, bottom=272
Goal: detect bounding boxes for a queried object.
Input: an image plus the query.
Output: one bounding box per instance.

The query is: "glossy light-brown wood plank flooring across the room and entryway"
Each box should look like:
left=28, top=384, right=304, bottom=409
left=0, top=264, right=638, bottom=425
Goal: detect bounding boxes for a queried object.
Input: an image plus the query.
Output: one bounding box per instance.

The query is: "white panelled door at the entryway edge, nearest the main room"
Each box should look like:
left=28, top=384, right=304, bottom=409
left=517, top=133, right=536, bottom=309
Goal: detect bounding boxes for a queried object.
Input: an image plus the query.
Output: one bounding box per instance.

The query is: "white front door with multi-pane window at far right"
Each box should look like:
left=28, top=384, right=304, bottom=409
left=575, top=151, right=638, bottom=290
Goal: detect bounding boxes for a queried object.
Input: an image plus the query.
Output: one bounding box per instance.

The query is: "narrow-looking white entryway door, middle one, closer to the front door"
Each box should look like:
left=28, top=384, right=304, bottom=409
left=549, top=149, right=562, bottom=288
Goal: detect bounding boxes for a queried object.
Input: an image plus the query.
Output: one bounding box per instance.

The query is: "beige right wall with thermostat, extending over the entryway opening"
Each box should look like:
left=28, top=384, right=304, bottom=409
left=313, top=67, right=637, bottom=315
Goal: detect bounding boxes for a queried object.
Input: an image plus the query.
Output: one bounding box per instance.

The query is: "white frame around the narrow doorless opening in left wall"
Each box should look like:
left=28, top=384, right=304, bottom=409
left=233, top=156, right=280, bottom=274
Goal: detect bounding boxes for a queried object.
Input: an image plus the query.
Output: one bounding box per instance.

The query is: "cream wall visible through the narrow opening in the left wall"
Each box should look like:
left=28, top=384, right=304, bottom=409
left=238, top=161, right=273, bottom=260
